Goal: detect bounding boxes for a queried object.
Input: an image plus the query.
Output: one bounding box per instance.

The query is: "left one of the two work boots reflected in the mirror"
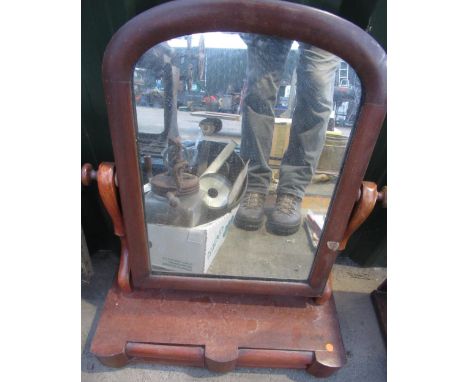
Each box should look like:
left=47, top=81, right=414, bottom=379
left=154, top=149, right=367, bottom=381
left=234, top=192, right=265, bottom=231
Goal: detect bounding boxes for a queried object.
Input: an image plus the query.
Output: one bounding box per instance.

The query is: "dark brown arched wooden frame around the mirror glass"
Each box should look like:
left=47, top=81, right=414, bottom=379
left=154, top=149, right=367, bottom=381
left=102, top=0, right=386, bottom=297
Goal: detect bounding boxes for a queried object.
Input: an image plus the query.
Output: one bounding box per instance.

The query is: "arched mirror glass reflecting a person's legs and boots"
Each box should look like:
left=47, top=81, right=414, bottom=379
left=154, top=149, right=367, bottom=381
left=133, top=32, right=361, bottom=280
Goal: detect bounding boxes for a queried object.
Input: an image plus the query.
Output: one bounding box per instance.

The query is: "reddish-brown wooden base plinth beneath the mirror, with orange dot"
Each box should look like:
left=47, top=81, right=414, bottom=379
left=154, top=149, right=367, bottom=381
left=91, top=284, right=346, bottom=377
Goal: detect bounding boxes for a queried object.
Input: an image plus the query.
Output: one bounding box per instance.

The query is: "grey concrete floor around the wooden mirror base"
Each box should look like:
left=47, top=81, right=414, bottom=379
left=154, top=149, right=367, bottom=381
left=81, top=253, right=387, bottom=382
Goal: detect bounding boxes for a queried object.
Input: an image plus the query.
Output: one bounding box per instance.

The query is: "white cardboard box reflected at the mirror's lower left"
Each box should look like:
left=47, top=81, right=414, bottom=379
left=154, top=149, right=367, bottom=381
left=147, top=207, right=238, bottom=274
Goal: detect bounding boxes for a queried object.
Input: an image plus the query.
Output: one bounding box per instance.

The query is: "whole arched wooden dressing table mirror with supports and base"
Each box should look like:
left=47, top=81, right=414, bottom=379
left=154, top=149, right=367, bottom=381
left=82, top=0, right=386, bottom=377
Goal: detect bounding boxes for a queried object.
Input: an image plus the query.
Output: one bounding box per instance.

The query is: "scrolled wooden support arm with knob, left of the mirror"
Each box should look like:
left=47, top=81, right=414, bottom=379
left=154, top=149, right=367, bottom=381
left=81, top=162, right=132, bottom=293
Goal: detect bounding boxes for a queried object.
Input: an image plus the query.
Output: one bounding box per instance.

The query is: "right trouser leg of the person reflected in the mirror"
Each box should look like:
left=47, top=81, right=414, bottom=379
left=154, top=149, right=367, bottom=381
left=278, top=44, right=339, bottom=199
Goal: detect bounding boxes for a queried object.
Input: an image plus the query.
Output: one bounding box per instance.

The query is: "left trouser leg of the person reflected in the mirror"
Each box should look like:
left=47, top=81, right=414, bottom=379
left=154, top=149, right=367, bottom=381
left=240, top=35, right=291, bottom=194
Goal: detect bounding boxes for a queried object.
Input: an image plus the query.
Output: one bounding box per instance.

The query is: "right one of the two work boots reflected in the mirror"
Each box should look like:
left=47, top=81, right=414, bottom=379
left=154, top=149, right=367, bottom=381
left=267, top=194, right=302, bottom=235
